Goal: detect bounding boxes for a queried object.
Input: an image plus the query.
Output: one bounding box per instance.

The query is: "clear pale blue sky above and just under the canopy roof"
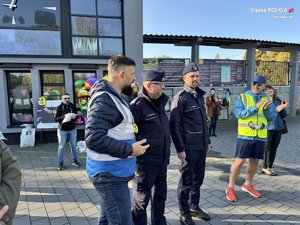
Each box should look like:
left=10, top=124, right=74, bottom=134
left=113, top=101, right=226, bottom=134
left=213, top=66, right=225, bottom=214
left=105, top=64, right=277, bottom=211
left=143, top=0, right=300, bottom=59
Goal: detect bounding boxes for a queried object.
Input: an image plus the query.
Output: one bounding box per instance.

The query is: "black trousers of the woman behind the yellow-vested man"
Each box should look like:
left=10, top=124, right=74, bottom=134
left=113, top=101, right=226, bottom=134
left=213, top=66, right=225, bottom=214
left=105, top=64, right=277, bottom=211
left=263, top=130, right=281, bottom=169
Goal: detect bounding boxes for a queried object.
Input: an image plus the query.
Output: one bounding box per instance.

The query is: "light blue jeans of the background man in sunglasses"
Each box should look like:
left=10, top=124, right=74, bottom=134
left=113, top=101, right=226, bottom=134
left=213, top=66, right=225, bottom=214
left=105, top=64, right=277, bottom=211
left=57, top=128, right=77, bottom=163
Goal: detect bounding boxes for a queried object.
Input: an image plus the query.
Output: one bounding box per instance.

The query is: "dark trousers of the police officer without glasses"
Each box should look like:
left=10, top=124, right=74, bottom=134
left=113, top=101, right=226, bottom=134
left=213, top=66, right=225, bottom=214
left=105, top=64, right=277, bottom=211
left=177, top=149, right=206, bottom=216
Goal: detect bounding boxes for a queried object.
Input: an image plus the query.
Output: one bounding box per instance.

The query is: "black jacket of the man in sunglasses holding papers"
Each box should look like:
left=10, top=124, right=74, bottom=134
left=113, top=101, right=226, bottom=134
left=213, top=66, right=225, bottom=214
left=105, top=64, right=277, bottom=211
left=54, top=103, right=77, bottom=131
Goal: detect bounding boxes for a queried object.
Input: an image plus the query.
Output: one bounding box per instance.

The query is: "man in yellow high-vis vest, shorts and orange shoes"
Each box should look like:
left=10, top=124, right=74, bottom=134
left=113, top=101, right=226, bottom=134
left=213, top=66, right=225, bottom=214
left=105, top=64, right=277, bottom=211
left=226, top=75, right=276, bottom=202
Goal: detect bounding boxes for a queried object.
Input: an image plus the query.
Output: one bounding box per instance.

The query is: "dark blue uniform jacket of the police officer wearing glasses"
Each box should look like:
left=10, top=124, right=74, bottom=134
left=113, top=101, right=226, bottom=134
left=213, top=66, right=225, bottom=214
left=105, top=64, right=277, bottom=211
left=130, top=89, right=171, bottom=165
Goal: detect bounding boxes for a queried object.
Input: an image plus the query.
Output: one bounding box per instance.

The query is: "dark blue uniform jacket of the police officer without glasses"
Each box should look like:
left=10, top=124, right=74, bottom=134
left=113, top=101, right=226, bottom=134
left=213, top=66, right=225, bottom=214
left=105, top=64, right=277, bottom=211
left=170, top=87, right=210, bottom=152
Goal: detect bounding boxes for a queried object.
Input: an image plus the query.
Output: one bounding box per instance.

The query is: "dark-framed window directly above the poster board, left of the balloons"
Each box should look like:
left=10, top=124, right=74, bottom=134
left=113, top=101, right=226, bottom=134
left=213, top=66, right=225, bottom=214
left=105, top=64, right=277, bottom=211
left=41, top=71, right=65, bottom=100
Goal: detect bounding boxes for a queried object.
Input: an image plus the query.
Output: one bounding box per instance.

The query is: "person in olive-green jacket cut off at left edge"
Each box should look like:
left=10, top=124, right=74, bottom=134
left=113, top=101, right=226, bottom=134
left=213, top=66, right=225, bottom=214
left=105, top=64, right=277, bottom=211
left=0, top=132, right=22, bottom=225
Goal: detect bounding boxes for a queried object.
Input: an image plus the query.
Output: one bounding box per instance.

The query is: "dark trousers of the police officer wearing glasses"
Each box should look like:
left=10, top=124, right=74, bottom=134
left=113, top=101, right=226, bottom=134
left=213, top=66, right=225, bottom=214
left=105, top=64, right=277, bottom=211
left=131, top=164, right=167, bottom=225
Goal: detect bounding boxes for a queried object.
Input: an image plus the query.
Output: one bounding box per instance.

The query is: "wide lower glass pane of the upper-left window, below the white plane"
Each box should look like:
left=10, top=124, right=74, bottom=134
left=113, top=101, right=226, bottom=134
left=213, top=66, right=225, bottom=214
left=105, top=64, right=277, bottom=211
left=0, top=29, right=61, bottom=55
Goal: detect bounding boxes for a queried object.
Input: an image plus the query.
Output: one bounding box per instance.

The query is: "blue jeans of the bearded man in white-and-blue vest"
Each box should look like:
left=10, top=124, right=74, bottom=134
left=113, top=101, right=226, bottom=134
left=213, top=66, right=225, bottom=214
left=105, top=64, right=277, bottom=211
left=90, top=174, right=132, bottom=225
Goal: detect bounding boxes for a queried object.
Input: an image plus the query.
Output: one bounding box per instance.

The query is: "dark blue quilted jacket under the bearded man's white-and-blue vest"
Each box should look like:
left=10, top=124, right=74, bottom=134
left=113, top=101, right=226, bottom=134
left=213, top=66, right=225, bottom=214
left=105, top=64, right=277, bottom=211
left=85, top=80, right=132, bottom=158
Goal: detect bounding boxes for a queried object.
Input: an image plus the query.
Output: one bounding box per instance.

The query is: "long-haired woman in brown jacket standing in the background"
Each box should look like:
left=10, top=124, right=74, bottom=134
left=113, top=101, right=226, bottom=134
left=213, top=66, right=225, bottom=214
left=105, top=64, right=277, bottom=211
left=206, top=88, right=222, bottom=137
